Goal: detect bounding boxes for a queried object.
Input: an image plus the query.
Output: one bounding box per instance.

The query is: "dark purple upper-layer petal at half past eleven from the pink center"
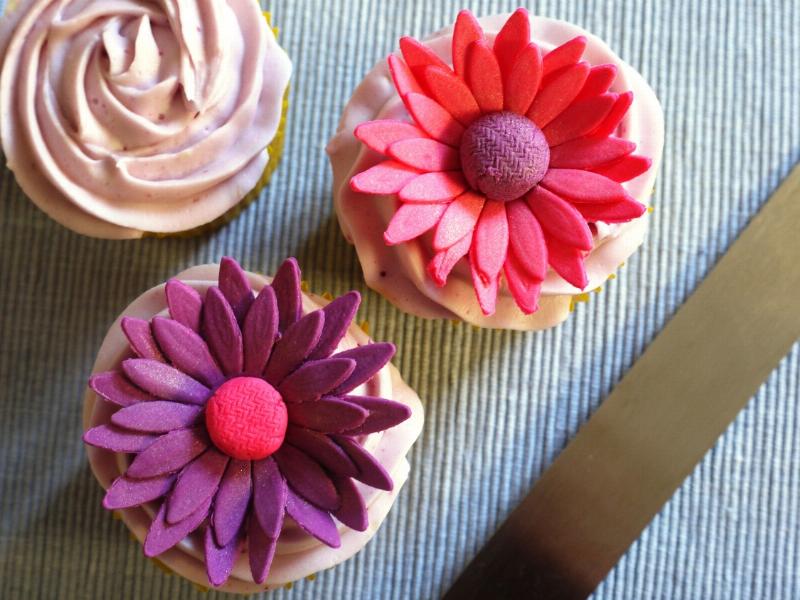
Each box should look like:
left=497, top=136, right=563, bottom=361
left=203, top=287, right=244, bottom=375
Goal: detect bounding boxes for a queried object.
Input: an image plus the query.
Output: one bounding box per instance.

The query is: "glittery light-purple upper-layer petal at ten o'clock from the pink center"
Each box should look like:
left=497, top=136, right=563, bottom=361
left=122, top=358, right=211, bottom=404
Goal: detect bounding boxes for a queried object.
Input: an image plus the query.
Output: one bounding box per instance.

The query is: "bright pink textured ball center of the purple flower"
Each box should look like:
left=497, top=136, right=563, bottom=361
left=206, top=377, right=288, bottom=460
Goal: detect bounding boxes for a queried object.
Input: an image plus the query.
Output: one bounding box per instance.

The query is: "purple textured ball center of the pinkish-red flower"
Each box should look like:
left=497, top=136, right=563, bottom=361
left=461, top=112, right=550, bottom=202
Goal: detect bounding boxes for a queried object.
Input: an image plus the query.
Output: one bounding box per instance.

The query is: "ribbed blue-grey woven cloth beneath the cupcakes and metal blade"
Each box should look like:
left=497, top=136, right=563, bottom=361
left=0, top=0, right=800, bottom=600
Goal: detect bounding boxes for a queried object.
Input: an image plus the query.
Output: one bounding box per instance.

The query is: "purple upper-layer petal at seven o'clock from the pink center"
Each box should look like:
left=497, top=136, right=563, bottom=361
left=167, top=448, right=229, bottom=523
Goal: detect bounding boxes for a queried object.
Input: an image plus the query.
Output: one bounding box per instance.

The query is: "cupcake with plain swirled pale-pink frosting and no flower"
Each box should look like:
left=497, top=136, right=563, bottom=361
left=0, top=0, right=291, bottom=238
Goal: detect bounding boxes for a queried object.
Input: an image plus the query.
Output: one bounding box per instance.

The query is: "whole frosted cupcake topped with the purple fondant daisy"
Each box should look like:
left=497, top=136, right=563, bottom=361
left=83, top=258, right=423, bottom=593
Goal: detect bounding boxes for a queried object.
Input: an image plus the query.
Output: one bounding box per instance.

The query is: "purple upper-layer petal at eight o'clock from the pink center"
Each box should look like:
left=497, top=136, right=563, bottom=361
left=126, top=429, right=208, bottom=479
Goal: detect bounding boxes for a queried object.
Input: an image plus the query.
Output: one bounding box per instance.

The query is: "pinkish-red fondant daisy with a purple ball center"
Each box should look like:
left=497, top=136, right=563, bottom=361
left=350, top=9, right=651, bottom=315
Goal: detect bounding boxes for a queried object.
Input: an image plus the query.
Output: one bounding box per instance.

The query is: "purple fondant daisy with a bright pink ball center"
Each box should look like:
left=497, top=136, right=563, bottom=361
left=84, top=258, right=410, bottom=586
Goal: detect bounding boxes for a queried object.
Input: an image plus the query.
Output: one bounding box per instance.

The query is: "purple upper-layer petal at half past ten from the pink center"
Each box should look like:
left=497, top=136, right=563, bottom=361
left=153, top=317, right=225, bottom=387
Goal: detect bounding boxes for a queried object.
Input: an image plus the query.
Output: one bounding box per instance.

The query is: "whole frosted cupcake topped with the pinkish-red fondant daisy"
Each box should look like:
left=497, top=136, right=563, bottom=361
left=328, top=9, right=663, bottom=330
